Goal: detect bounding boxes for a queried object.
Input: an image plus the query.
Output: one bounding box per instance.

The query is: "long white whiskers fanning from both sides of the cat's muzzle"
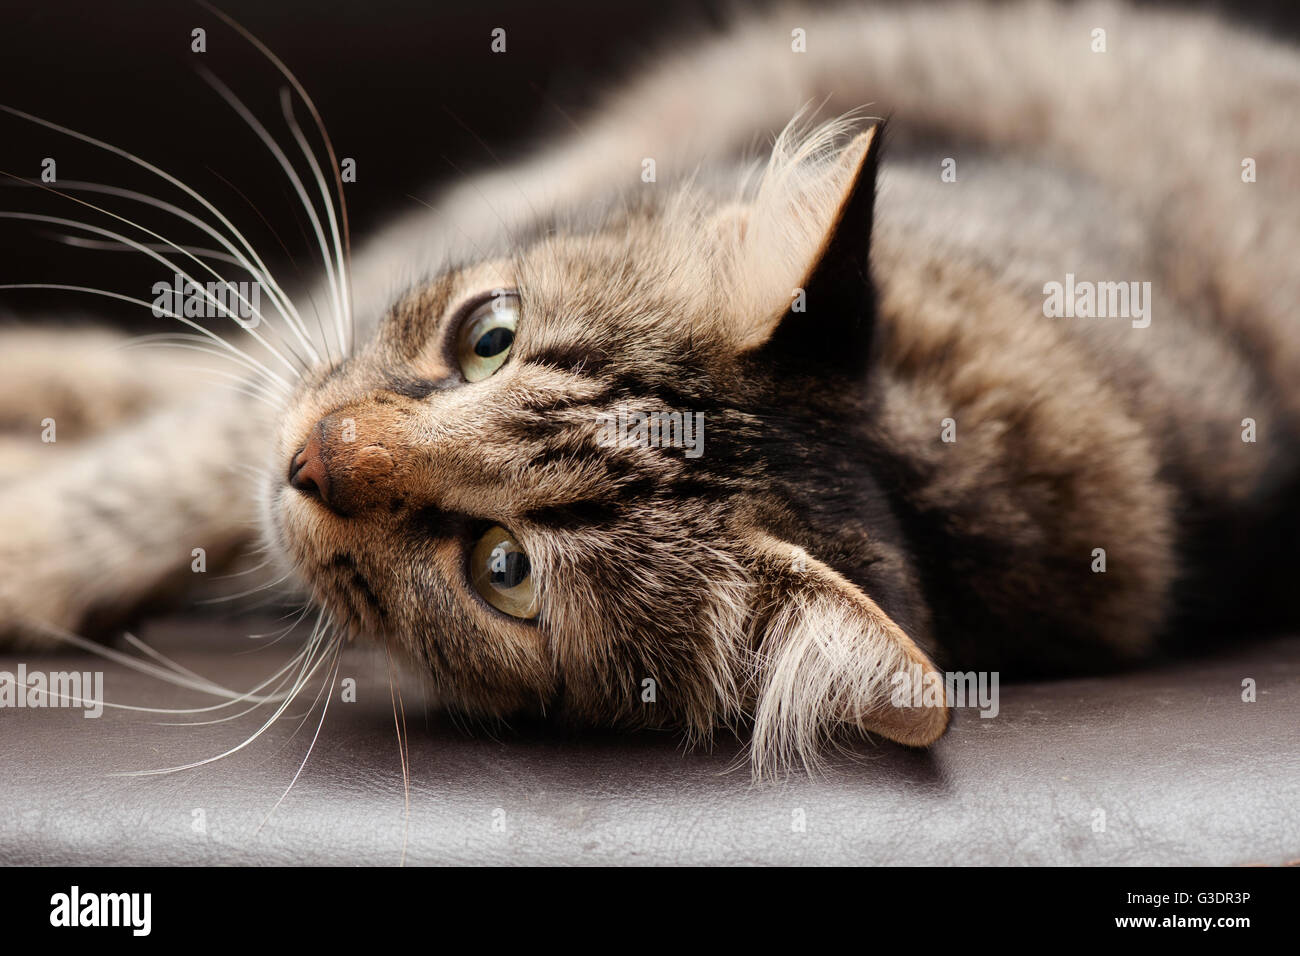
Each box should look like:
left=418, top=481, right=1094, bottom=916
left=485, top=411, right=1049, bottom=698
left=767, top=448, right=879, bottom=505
left=0, top=0, right=369, bottom=822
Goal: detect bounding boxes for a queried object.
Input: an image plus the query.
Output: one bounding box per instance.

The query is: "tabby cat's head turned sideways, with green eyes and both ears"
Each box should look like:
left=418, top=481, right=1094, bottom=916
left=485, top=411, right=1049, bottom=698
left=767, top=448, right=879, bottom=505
left=269, top=121, right=948, bottom=771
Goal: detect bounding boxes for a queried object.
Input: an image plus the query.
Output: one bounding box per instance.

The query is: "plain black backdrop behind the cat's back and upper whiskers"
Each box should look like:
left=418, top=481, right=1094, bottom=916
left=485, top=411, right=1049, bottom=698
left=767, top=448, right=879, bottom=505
left=0, top=0, right=1300, bottom=328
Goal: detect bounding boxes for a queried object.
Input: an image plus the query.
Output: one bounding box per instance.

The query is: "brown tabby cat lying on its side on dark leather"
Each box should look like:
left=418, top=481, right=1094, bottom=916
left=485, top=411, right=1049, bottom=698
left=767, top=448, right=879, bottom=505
left=0, top=3, right=1300, bottom=773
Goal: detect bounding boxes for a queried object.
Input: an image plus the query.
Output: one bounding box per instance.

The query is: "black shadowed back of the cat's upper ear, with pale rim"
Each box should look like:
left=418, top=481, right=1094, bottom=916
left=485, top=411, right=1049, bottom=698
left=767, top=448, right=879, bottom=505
left=759, top=124, right=883, bottom=375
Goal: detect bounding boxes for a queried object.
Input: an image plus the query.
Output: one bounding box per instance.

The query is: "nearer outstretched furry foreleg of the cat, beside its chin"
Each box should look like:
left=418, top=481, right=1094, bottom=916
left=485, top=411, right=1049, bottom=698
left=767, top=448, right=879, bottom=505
left=0, top=389, right=272, bottom=644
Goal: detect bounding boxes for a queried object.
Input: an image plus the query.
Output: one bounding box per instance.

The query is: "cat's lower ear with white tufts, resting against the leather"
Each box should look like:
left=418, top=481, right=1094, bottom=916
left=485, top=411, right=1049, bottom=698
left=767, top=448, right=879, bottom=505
left=753, top=533, right=948, bottom=774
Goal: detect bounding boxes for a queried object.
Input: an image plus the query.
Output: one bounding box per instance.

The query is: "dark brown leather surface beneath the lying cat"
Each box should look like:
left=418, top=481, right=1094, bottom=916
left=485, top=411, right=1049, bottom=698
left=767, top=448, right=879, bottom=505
left=0, top=622, right=1300, bottom=865
